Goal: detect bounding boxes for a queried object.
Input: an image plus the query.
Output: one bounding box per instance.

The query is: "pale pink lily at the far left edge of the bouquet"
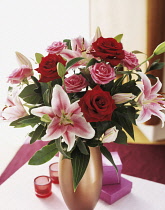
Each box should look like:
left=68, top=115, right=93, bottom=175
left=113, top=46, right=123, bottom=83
left=1, top=89, right=28, bottom=122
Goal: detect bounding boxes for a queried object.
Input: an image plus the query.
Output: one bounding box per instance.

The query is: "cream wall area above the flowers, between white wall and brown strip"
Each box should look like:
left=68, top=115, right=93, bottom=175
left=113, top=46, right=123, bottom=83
left=90, top=0, right=147, bottom=52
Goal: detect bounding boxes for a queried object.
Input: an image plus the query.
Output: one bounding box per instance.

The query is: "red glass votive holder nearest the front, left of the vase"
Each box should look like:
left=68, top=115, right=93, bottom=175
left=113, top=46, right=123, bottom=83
left=34, top=176, right=52, bottom=198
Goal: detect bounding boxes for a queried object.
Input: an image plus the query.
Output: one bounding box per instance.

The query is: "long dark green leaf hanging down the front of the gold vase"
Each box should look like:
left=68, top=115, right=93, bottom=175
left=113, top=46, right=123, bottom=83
left=71, top=148, right=90, bottom=192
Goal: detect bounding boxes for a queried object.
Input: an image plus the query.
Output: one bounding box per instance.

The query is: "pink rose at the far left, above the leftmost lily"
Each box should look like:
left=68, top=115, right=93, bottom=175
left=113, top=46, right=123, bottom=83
left=7, top=65, right=33, bottom=84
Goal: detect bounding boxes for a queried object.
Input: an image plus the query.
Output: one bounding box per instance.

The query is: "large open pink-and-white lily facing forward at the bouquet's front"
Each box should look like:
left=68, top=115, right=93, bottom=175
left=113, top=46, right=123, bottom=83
left=32, top=85, right=95, bottom=151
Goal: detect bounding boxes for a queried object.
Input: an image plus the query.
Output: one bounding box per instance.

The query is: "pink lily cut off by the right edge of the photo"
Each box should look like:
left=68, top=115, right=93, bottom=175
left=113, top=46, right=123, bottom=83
left=137, top=72, right=165, bottom=127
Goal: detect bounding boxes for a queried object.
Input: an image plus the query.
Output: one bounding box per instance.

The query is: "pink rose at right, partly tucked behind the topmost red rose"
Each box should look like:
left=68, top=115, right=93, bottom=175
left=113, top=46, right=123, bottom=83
left=121, top=50, right=139, bottom=70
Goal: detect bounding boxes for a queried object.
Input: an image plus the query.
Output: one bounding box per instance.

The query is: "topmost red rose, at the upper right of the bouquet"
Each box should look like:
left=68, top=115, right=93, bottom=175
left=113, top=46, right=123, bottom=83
left=91, top=37, right=124, bottom=66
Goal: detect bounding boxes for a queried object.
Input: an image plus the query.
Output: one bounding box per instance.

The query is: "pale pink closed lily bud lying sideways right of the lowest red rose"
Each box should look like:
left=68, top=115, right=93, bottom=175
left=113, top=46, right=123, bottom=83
left=112, top=93, right=136, bottom=104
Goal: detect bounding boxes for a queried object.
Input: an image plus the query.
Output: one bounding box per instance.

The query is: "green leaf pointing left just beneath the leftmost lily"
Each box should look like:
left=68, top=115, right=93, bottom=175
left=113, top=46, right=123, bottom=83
left=10, top=115, right=41, bottom=128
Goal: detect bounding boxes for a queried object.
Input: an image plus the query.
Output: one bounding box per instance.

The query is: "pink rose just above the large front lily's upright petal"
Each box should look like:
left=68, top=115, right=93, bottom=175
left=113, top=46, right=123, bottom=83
left=65, top=74, right=88, bottom=93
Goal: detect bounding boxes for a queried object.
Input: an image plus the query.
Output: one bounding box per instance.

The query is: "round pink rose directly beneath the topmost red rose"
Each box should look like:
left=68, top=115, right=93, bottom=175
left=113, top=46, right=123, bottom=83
left=89, top=63, right=116, bottom=84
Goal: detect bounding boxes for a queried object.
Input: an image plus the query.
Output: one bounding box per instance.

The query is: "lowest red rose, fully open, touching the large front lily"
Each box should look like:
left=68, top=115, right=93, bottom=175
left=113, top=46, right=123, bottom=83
left=78, top=85, right=116, bottom=122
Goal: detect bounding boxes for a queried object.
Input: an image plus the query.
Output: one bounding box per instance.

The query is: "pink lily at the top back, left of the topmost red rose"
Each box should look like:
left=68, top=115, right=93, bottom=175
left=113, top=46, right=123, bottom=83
left=60, top=36, right=93, bottom=68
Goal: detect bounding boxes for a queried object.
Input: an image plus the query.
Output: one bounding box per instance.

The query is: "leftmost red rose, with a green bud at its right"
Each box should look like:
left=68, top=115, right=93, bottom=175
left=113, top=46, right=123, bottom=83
left=35, top=54, right=66, bottom=82
